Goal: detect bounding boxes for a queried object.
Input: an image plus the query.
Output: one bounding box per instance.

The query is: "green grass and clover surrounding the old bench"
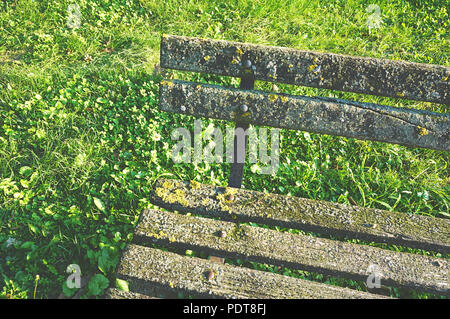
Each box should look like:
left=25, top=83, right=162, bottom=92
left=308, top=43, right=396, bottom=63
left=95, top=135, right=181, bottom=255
left=0, top=0, right=450, bottom=298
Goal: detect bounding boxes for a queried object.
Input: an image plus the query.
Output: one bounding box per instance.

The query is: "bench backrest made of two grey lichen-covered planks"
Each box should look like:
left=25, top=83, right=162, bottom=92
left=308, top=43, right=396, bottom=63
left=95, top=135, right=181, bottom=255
left=160, top=35, right=450, bottom=151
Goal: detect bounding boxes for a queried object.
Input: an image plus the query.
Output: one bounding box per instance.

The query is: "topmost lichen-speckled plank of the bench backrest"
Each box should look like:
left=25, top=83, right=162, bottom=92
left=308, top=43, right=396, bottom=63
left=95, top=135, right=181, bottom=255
left=160, top=35, right=450, bottom=105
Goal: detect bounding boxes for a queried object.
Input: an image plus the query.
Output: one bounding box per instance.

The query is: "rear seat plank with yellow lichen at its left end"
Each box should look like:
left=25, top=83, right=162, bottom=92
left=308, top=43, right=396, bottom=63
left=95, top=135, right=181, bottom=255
left=150, top=179, right=450, bottom=254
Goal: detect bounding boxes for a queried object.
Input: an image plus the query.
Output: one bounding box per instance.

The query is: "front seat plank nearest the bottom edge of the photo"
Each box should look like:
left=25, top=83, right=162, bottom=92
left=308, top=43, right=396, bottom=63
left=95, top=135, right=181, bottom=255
left=118, top=244, right=383, bottom=299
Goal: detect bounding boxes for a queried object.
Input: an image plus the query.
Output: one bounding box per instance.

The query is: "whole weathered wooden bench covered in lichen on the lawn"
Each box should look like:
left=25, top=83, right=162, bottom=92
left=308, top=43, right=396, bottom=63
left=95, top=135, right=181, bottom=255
left=107, top=36, right=450, bottom=298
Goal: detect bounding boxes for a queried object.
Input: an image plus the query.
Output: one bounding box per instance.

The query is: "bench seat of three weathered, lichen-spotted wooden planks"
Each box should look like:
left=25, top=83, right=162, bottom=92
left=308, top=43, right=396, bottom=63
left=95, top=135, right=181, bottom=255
left=108, top=179, right=450, bottom=298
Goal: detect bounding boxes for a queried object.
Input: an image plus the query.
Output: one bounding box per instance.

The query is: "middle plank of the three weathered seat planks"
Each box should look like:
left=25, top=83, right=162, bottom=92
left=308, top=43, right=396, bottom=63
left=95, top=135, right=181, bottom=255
left=135, top=210, right=450, bottom=294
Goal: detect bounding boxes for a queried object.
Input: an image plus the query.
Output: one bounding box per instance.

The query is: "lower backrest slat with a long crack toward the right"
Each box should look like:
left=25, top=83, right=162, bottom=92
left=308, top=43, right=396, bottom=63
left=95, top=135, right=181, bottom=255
left=160, top=81, right=450, bottom=151
